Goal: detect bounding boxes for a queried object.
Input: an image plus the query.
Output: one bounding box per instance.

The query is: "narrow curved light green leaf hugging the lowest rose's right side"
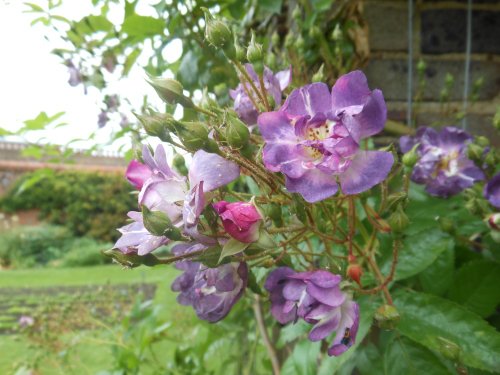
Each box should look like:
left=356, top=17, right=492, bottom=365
left=318, top=297, right=378, bottom=375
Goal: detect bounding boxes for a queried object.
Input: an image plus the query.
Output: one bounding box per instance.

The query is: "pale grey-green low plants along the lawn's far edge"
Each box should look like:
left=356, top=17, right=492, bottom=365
left=0, top=225, right=111, bottom=268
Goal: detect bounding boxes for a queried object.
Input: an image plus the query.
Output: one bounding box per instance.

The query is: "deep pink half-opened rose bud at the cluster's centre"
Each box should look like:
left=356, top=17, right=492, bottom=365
left=213, top=201, right=262, bottom=243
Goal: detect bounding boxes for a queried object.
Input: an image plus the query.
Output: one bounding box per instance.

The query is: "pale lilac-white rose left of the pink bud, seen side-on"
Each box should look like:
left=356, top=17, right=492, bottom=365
left=114, top=145, right=240, bottom=255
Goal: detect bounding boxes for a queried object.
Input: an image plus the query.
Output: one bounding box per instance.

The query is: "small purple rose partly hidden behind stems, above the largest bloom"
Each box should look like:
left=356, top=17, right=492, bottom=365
left=229, top=64, right=292, bottom=126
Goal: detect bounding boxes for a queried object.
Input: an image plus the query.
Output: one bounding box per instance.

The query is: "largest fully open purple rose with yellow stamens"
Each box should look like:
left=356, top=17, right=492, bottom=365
left=258, top=71, right=394, bottom=202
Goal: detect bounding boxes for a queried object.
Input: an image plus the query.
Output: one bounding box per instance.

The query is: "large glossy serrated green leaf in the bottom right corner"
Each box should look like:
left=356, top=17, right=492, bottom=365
left=394, top=291, right=500, bottom=371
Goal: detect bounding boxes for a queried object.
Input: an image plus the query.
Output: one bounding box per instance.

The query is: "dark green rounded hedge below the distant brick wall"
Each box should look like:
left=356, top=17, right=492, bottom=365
left=0, top=170, right=137, bottom=241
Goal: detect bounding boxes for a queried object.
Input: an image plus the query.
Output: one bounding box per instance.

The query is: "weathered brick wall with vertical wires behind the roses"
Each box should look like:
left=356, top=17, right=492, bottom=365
left=364, top=0, right=500, bottom=145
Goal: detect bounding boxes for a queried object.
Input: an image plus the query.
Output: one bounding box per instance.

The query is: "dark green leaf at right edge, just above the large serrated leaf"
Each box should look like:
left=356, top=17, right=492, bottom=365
left=449, top=260, right=500, bottom=317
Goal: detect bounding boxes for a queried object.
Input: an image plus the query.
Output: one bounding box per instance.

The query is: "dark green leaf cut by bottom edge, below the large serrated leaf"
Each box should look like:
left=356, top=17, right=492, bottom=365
left=384, top=337, right=453, bottom=375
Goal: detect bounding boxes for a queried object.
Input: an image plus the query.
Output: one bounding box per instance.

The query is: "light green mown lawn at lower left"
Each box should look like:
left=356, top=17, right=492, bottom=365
left=0, top=265, right=186, bottom=375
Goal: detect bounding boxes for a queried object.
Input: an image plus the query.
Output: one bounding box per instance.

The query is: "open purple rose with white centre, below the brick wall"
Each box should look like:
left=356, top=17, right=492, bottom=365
left=399, top=127, right=484, bottom=197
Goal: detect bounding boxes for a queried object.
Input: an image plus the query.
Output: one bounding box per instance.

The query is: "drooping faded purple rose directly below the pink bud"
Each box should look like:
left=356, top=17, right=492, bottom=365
left=172, top=244, right=248, bottom=323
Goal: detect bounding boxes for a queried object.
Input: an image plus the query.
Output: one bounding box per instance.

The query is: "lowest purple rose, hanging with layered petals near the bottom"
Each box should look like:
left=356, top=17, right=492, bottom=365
left=265, top=267, right=359, bottom=356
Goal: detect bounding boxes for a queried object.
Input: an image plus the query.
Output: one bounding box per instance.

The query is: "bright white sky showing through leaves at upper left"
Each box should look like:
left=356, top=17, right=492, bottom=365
left=0, top=0, right=181, bottom=150
